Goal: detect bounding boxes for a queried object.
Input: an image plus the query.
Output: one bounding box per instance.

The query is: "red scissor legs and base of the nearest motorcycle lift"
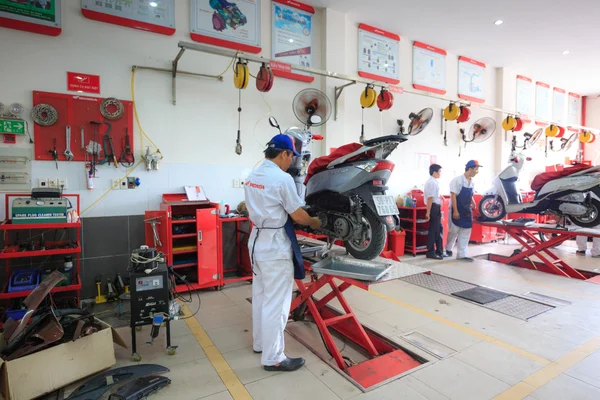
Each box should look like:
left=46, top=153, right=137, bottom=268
left=290, top=261, right=422, bottom=389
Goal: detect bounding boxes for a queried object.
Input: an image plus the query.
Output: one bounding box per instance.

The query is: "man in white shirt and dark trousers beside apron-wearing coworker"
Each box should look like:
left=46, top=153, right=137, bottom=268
left=423, top=164, right=445, bottom=260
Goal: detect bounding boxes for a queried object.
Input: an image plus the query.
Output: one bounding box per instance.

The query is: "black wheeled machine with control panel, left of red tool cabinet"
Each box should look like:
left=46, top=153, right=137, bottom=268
left=129, top=246, right=177, bottom=361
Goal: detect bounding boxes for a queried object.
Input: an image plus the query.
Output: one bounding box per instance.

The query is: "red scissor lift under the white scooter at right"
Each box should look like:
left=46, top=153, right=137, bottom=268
left=477, top=221, right=600, bottom=284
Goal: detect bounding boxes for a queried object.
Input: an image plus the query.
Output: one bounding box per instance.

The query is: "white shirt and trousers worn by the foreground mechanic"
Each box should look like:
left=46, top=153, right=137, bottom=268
left=244, top=160, right=304, bottom=366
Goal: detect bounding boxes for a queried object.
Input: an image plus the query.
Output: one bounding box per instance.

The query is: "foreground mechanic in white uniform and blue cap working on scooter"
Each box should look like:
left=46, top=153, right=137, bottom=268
left=244, top=134, right=321, bottom=371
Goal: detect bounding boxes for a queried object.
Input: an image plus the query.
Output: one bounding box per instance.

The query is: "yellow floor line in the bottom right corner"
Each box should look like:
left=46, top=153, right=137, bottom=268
left=493, top=336, right=600, bottom=400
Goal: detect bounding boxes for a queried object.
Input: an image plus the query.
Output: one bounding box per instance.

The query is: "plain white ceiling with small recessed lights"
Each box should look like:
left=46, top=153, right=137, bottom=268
left=307, top=0, right=600, bottom=95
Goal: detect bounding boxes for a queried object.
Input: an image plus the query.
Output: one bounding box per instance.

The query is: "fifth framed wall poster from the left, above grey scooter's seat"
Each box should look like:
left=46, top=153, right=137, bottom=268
left=358, top=24, right=400, bottom=85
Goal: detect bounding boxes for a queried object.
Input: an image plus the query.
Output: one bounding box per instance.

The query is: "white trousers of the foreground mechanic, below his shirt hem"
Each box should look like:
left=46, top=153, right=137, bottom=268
left=252, top=259, right=294, bottom=365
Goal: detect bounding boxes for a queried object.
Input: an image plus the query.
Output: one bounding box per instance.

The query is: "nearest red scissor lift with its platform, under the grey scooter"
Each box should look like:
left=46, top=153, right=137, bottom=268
left=286, top=236, right=431, bottom=392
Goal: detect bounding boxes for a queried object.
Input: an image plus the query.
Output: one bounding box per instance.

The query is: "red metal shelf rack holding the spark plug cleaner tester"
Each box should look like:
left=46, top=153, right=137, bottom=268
left=0, top=193, right=81, bottom=303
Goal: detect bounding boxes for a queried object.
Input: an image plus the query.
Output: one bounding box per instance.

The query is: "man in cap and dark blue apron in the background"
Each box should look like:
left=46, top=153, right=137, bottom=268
left=446, top=160, right=481, bottom=261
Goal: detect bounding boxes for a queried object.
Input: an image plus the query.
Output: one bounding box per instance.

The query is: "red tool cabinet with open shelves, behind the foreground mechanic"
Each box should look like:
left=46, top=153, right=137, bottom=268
left=144, top=193, right=252, bottom=292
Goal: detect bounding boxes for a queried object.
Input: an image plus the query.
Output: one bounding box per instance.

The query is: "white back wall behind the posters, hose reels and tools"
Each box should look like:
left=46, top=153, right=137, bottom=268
left=0, top=1, right=592, bottom=216
